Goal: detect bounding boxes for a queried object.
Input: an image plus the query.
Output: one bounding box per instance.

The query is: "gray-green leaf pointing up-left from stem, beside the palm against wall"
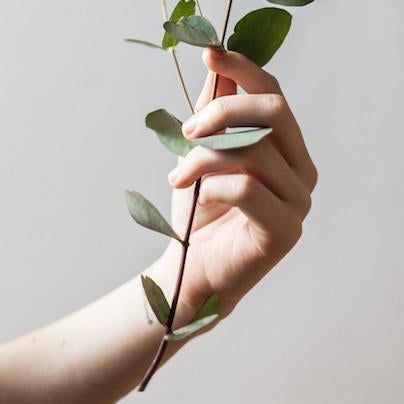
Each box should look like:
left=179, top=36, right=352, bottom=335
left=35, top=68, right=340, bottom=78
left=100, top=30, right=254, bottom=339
left=125, top=191, right=182, bottom=242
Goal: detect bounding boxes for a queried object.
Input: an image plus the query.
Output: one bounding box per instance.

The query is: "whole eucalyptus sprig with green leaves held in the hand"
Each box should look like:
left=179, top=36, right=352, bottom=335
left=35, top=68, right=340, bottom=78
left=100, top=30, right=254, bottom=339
left=126, top=0, right=314, bottom=391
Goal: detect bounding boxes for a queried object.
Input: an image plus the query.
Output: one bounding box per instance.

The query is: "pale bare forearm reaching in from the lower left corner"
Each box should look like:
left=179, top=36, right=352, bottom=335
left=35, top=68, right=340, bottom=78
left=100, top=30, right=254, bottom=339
left=0, top=259, right=199, bottom=404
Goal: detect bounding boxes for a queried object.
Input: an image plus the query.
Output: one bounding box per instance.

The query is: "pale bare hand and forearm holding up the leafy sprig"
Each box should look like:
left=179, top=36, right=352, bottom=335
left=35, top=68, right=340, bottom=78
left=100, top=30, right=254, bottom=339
left=0, top=49, right=317, bottom=404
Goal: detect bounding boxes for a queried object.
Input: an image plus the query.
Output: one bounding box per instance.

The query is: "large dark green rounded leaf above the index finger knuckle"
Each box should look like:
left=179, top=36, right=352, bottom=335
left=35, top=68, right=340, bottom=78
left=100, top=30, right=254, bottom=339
left=227, top=8, right=292, bottom=66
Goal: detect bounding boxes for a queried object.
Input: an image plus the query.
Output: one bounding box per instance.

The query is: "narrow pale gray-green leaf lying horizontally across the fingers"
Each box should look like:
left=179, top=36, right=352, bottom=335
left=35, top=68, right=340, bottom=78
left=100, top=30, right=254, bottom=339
left=193, top=128, right=272, bottom=150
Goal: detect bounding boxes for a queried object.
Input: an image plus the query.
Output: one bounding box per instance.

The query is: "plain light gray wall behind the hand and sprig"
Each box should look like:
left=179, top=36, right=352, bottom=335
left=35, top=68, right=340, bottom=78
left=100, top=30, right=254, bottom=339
left=0, top=0, right=404, bottom=404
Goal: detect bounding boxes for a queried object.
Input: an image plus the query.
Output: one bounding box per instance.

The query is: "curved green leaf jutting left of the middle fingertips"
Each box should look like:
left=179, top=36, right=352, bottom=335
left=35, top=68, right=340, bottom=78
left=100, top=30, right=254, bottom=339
left=146, top=109, right=195, bottom=156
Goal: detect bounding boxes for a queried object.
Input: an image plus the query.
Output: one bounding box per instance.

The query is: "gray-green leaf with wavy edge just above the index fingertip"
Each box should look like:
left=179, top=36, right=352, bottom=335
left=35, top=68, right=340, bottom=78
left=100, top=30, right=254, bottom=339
left=164, top=15, right=223, bottom=49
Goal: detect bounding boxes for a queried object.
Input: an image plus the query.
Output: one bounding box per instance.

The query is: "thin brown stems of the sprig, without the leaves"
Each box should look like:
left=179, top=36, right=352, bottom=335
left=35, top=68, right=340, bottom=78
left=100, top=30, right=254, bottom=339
left=139, top=0, right=233, bottom=391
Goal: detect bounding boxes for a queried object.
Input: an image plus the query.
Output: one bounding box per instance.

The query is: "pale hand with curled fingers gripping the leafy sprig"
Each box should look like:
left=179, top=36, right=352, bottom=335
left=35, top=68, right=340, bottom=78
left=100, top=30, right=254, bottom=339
left=157, top=49, right=317, bottom=316
